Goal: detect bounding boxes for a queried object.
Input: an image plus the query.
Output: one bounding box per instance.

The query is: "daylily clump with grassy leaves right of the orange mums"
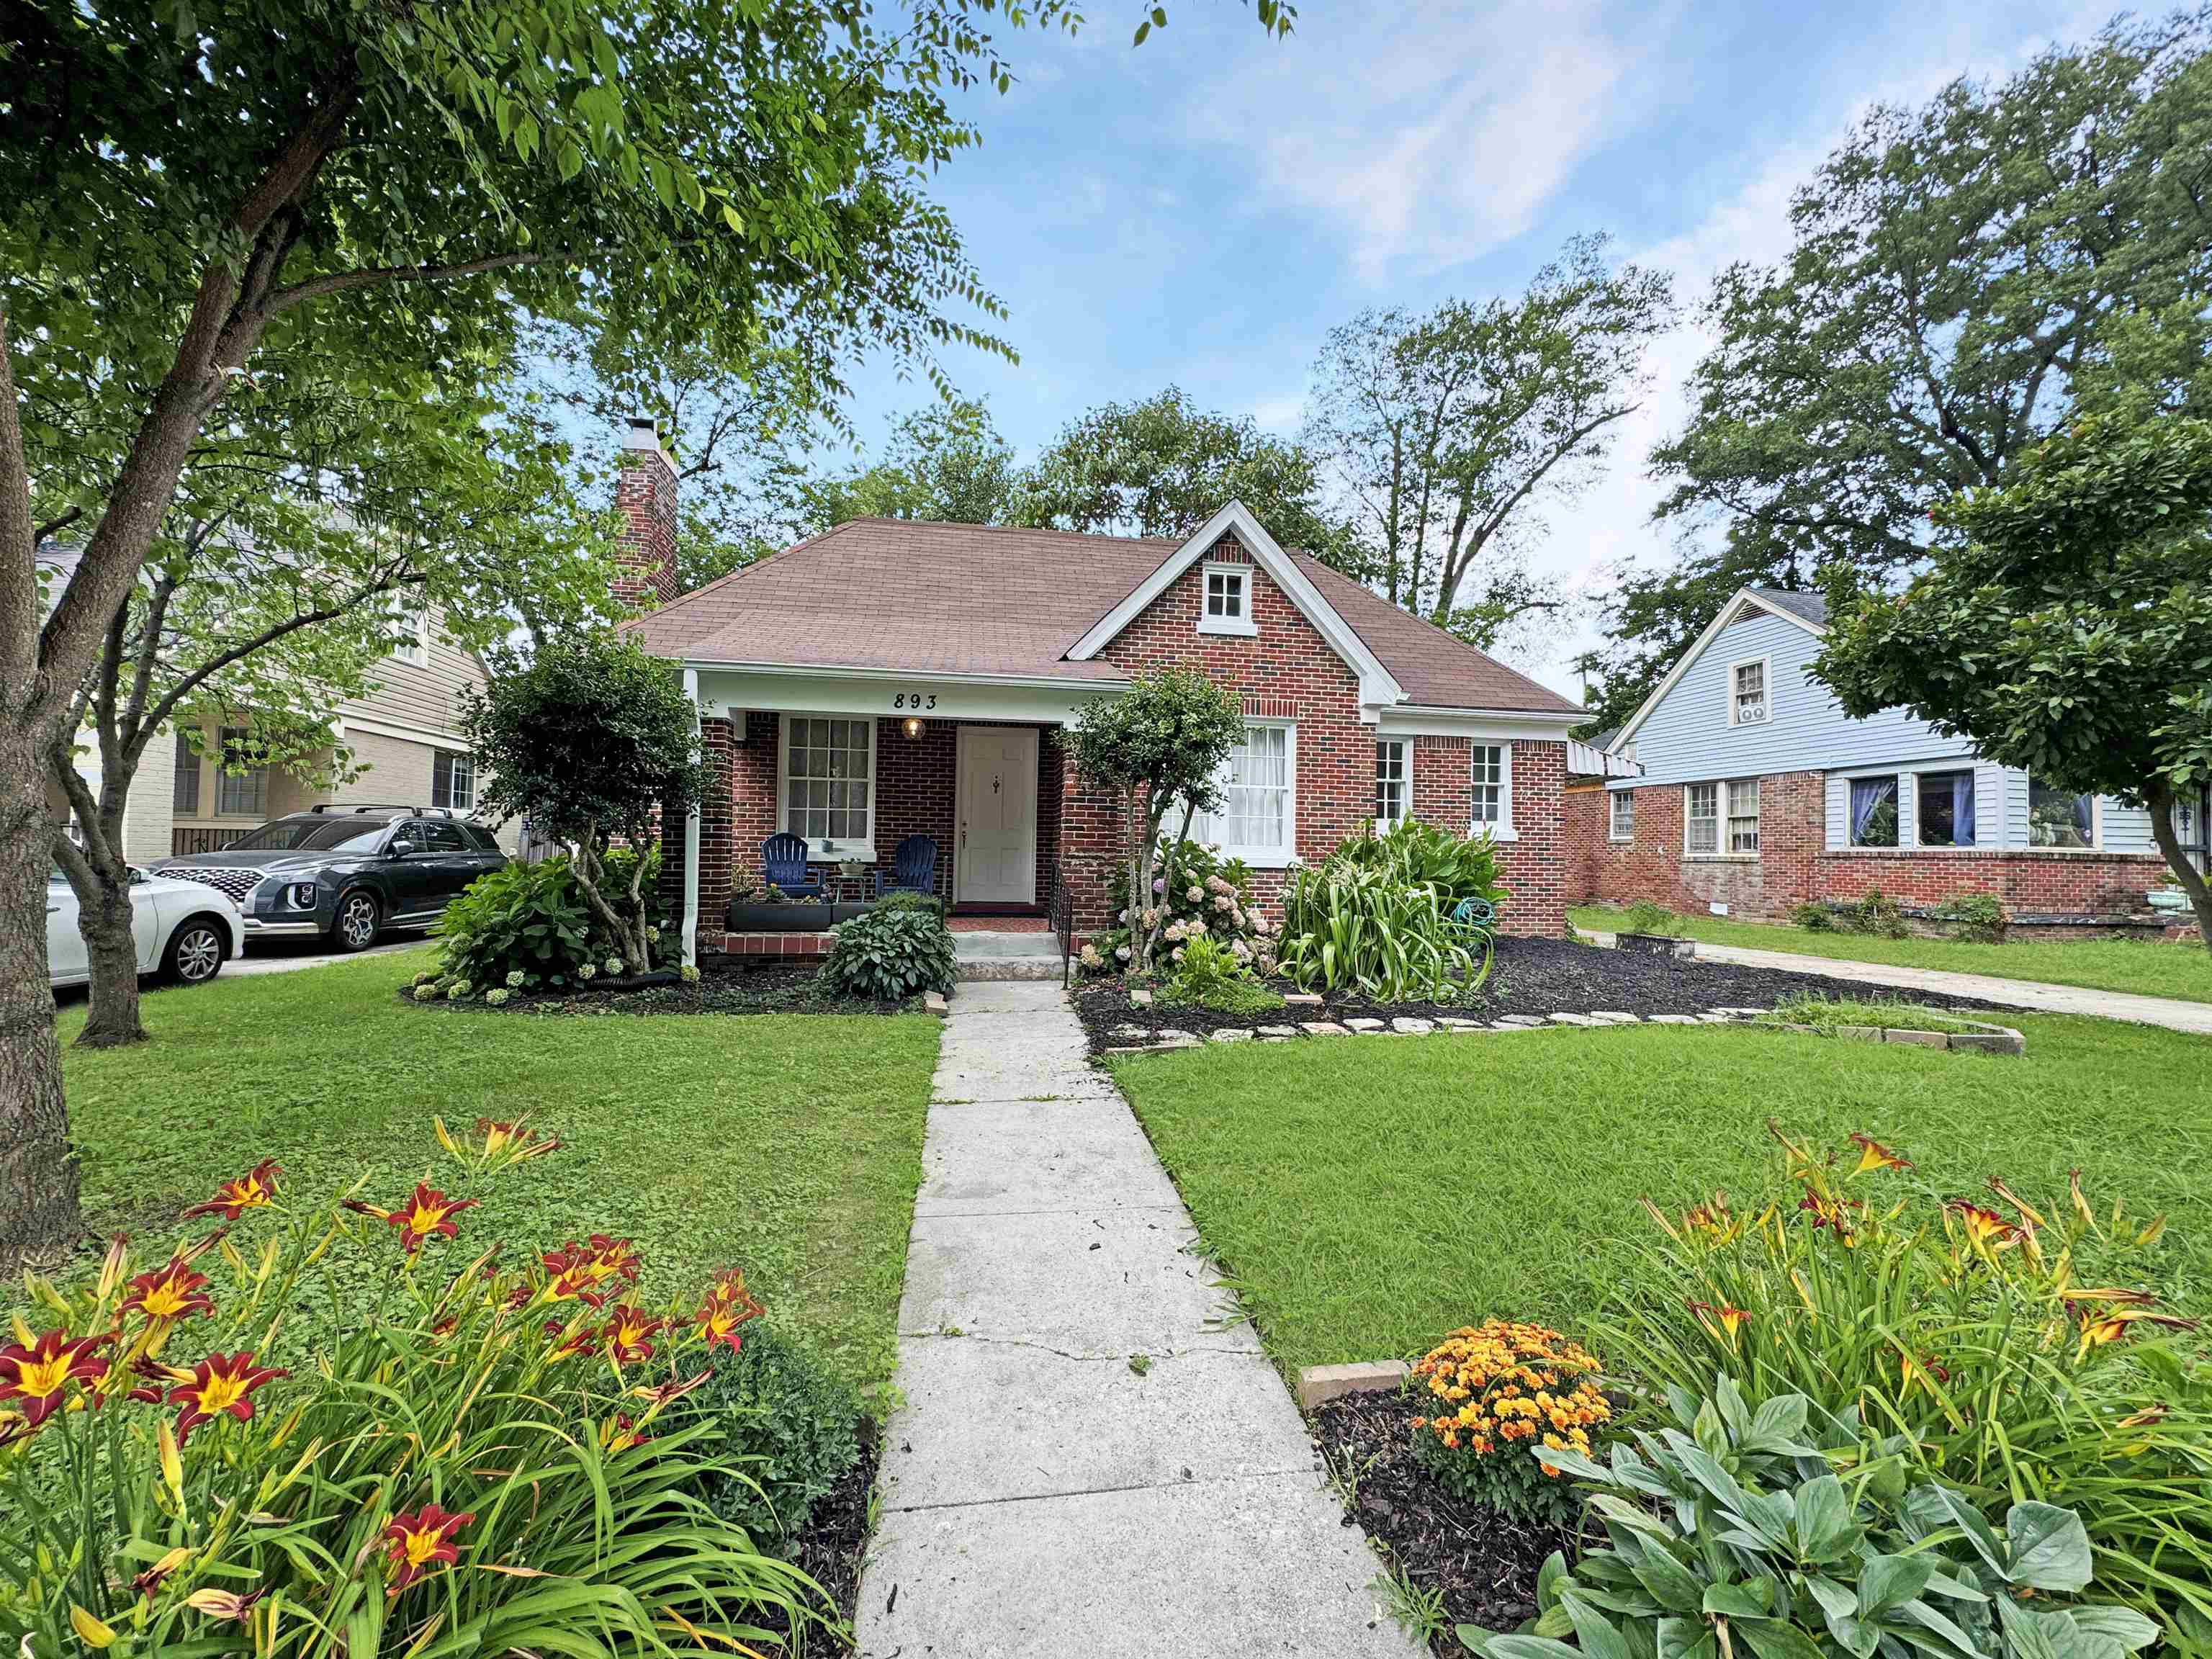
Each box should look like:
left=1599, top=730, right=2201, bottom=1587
left=1597, top=1126, right=2212, bottom=1643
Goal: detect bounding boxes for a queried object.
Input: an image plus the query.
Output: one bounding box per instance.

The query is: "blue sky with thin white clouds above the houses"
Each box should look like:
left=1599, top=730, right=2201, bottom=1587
left=852, top=0, right=2110, bottom=693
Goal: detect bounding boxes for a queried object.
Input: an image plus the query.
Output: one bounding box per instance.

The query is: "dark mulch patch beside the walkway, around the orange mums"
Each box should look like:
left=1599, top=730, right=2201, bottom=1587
left=1314, top=1391, right=1575, bottom=1659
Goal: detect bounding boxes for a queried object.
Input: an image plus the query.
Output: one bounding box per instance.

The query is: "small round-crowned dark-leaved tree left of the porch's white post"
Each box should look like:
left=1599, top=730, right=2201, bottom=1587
left=460, top=635, right=708, bottom=974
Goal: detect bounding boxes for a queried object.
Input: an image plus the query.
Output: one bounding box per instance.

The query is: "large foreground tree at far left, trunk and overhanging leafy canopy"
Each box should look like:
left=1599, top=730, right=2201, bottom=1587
left=0, top=0, right=1287, bottom=1256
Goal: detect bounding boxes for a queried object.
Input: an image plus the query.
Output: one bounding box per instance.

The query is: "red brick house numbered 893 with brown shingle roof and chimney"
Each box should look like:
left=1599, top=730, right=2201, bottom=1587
left=617, top=425, right=1581, bottom=951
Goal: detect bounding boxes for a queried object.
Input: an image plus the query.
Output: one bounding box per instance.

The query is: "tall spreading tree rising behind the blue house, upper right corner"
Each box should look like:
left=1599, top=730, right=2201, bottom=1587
left=1599, top=11, right=2212, bottom=721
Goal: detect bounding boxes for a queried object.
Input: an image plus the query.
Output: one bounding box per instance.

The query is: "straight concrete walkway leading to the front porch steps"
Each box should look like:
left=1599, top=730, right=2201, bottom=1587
left=856, top=982, right=1418, bottom=1659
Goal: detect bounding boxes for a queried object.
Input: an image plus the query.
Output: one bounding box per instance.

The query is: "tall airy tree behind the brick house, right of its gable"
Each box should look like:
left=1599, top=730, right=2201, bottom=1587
left=1305, top=237, right=1672, bottom=646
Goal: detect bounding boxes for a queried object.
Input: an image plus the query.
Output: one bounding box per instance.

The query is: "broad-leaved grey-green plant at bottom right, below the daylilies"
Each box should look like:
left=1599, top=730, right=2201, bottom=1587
left=1457, top=1376, right=2159, bottom=1659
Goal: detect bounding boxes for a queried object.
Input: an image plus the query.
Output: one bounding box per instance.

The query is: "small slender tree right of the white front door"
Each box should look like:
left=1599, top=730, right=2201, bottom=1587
left=1075, top=668, right=1243, bottom=974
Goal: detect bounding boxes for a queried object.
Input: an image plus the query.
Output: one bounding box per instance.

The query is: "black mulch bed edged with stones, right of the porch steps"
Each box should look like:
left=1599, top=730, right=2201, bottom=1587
left=1075, top=938, right=2004, bottom=1053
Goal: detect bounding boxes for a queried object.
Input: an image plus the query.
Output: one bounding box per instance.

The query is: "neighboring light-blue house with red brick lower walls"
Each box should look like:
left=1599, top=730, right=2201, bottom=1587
left=1586, top=588, right=2208, bottom=927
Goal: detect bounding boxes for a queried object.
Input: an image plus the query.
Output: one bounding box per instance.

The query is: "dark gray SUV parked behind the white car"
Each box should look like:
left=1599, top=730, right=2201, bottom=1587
left=155, top=805, right=506, bottom=951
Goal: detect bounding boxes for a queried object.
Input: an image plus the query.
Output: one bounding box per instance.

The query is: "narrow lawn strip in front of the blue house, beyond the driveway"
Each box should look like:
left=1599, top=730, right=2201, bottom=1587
left=1566, top=904, right=2212, bottom=1002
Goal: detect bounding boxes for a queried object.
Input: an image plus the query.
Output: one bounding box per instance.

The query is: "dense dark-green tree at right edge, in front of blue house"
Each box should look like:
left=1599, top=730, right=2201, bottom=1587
left=1814, top=413, right=2212, bottom=945
